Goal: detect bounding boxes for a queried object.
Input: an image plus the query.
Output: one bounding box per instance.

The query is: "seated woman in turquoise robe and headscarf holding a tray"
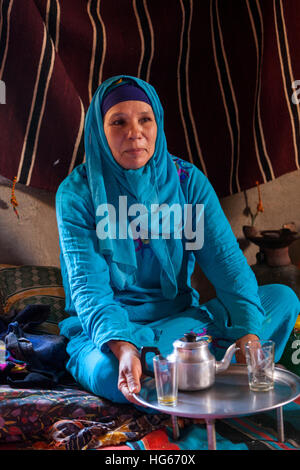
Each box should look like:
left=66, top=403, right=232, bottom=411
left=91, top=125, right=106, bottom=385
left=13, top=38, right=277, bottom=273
left=56, top=76, right=300, bottom=402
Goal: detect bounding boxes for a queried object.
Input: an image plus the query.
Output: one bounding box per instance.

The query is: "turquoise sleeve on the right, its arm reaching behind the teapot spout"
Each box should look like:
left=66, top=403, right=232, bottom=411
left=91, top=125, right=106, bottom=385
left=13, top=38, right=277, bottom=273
left=188, top=169, right=265, bottom=340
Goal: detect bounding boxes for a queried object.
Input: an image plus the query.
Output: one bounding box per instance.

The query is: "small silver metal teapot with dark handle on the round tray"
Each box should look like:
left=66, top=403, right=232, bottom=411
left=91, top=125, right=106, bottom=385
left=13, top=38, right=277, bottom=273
left=141, top=333, right=239, bottom=391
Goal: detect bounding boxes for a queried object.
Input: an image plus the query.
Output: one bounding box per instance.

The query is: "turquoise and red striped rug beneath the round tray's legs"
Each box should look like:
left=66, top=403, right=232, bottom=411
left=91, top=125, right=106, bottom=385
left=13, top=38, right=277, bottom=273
left=112, top=399, right=300, bottom=451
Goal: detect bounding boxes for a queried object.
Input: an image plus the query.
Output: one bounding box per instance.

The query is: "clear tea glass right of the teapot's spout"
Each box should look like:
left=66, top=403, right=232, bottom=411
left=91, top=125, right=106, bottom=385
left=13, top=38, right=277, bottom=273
left=245, top=340, right=275, bottom=392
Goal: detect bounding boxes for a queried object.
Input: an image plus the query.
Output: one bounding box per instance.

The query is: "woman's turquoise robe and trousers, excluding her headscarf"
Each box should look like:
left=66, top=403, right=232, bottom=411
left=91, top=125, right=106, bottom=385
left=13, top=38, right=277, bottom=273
left=56, top=157, right=300, bottom=402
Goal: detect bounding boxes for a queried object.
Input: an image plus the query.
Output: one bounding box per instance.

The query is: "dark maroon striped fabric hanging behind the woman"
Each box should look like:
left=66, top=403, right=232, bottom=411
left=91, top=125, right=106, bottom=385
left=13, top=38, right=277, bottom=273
left=0, top=0, right=300, bottom=197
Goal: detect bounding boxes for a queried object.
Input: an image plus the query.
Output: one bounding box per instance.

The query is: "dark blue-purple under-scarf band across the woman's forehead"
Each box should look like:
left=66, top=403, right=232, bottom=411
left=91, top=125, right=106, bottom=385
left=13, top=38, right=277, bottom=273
left=101, top=83, right=151, bottom=117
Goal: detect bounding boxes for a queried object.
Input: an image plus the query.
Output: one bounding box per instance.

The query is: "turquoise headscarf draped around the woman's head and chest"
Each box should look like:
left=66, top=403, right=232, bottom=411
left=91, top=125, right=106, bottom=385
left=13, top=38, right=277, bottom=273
left=85, top=75, right=186, bottom=299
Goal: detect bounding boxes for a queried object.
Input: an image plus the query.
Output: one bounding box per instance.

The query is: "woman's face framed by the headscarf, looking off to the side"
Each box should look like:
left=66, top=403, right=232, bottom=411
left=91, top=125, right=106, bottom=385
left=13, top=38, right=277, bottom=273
left=103, top=101, right=157, bottom=170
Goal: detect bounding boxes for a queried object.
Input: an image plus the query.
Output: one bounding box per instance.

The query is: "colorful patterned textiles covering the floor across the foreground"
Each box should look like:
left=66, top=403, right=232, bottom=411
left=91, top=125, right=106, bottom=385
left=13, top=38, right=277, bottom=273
left=0, top=385, right=300, bottom=451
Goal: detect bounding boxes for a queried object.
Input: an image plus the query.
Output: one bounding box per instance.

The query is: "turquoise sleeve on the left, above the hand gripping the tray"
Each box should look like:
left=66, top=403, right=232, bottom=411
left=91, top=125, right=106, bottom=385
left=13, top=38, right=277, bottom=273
left=56, top=166, right=153, bottom=350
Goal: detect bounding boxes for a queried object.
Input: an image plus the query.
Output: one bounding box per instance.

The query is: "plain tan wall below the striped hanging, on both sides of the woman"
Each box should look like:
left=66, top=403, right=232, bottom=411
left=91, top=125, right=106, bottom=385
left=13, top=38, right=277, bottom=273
left=0, top=171, right=300, bottom=266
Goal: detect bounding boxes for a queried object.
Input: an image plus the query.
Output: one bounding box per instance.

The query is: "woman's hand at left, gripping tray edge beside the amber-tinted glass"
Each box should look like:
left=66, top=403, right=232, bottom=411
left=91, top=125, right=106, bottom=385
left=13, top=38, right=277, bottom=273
left=108, top=340, right=142, bottom=405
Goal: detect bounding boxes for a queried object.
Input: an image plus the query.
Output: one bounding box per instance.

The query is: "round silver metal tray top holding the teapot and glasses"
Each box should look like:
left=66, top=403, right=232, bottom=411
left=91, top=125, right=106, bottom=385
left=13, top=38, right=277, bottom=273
left=135, top=364, right=300, bottom=419
